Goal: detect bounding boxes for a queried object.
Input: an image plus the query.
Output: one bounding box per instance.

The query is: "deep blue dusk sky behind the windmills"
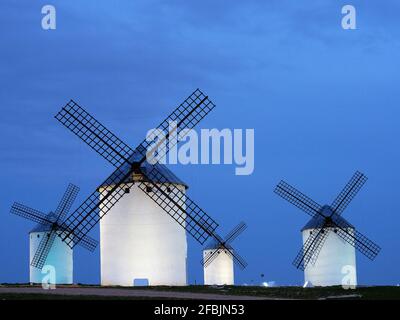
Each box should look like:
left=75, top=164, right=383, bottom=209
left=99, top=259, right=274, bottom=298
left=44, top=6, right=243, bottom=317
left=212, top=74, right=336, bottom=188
left=0, top=0, right=400, bottom=284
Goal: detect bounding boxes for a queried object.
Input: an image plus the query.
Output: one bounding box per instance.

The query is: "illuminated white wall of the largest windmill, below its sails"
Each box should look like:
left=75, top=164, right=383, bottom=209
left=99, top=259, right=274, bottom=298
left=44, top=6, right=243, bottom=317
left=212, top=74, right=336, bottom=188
left=100, top=185, right=187, bottom=286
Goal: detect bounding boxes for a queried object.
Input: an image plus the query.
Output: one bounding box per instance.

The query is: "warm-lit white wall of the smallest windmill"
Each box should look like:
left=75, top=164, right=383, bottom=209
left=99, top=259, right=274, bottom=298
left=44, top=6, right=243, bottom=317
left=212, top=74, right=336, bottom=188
left=203, top=250, right=235, bottom=286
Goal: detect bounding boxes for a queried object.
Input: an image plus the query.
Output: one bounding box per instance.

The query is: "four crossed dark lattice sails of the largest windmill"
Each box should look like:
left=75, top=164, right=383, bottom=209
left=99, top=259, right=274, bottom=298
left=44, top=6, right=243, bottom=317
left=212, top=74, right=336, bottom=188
left=56, top=89, right=222, bottom=247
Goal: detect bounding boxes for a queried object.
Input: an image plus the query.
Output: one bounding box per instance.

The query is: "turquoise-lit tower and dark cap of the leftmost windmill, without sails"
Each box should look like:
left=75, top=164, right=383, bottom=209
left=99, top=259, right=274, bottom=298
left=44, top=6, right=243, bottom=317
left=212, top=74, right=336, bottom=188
left=29, top=225, right=73, bottom=284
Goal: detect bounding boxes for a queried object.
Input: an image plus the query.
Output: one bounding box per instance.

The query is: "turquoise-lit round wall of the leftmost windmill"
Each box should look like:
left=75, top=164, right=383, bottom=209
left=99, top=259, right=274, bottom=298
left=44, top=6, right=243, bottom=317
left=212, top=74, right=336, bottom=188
left=29, top=232, right=73, bottom=284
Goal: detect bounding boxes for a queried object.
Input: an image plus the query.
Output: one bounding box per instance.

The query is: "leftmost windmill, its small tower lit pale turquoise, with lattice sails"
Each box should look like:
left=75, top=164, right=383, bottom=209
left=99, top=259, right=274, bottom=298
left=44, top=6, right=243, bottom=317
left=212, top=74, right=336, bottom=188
left=10, top=184, right=97, bottom=284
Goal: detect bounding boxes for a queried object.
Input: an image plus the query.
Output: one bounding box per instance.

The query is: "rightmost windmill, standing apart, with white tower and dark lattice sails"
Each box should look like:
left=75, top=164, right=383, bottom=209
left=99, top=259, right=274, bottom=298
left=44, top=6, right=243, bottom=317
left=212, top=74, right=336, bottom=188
left=275, top=171, right=380, bottom=286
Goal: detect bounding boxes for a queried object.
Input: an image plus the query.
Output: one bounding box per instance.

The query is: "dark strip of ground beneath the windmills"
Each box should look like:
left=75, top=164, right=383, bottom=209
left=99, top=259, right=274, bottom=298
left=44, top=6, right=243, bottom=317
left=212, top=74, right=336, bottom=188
left=0, top=284, right=400, bottom=300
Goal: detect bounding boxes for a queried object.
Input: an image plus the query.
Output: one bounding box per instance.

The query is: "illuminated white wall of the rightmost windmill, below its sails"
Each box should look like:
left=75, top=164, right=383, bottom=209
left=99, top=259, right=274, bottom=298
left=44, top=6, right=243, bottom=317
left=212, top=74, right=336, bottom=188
left=302, top=229, right=357, bottom=286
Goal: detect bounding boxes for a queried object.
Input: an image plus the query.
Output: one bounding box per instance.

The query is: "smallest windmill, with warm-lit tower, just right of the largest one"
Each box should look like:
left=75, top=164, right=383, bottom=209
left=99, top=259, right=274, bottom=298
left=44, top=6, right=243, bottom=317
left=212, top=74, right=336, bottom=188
left=202, top=222, right=247, bottom=285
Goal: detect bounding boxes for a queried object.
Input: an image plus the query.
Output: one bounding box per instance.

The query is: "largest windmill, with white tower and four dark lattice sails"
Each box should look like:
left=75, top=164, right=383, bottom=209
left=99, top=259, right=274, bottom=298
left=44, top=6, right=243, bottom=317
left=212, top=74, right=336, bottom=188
left=55, top=89, right=247, bottom=286
